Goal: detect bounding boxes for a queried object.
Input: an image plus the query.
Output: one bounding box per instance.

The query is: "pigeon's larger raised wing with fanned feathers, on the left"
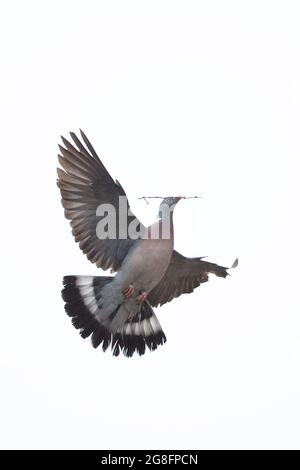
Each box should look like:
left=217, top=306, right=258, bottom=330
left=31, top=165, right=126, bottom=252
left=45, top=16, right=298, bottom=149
left=57, top=131, right=144, bottom=271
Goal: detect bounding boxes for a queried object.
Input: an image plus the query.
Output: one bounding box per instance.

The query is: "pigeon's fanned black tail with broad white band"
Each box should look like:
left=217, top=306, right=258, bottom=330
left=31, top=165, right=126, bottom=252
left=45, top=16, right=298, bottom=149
left=62, top=276, right=166, bottom=357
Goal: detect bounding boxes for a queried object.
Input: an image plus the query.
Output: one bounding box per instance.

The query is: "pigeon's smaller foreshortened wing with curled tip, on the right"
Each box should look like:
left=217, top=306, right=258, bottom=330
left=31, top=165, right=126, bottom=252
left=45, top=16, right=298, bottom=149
left=148, top=250, right=238, bottom=307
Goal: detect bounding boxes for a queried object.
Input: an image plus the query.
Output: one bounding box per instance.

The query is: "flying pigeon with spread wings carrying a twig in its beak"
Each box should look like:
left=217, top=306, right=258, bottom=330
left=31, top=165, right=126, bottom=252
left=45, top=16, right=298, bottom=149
left=57, top=130, right=238, bottom=357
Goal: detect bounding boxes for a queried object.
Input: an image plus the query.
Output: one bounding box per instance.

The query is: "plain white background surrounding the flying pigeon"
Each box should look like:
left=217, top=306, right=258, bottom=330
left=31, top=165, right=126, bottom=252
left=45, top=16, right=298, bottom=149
left=0, top=0, right=300, bottom=449
